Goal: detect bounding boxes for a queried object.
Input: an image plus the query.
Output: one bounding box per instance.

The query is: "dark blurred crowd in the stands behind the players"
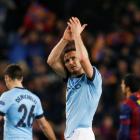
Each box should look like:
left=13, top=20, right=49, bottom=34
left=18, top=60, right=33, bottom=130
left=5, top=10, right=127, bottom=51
left=0, top=0, right=140, bottom=140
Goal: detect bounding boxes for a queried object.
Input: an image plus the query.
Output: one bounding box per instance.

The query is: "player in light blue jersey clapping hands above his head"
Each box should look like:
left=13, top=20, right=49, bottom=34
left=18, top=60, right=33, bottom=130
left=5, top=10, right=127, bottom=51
left=47, top=17, right=102, bottom=140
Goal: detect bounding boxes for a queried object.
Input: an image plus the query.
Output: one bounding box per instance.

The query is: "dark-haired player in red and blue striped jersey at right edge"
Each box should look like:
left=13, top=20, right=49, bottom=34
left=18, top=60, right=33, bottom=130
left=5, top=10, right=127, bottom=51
left=118, top=74, right=140, bottom=140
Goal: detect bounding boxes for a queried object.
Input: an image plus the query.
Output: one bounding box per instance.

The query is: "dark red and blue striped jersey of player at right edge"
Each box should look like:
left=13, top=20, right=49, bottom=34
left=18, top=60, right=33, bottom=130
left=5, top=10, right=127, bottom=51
left=118, top=92, right=140, bottom=140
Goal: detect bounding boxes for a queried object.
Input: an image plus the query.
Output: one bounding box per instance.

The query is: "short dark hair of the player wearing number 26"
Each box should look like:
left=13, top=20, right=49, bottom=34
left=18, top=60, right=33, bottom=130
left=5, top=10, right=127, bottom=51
left=4, top=64, right=23, bottom=80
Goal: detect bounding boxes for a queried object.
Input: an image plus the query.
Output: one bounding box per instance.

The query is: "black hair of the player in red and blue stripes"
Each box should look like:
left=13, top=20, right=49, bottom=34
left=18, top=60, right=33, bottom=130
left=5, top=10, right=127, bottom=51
left=123, top=74, right=140, bottom=93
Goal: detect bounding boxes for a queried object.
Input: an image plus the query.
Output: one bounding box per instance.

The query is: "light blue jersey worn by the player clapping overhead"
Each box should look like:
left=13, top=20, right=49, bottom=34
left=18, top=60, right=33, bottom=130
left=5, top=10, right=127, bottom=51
left=65, top=67, right=102, bottom=138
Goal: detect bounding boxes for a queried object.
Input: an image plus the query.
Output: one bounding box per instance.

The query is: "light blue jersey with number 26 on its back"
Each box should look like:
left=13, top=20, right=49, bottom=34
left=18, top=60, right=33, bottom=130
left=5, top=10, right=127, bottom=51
left=0, top=87, right=43, bottom=140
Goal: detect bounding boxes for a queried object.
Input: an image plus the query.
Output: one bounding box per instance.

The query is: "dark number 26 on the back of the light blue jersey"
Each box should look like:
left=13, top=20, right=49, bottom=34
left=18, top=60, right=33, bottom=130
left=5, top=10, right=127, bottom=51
left=16, top=104, right=35, bottom=127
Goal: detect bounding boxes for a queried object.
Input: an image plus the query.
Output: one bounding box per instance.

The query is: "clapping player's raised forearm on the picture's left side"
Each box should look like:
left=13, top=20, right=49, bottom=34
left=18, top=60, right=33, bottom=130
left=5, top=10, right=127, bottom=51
left=47, top=38, right=68, bottom=65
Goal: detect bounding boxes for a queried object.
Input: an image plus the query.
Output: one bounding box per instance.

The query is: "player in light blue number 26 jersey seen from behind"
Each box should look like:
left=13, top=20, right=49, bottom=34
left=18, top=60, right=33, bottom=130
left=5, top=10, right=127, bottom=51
left=0, top=64, right=56, bottom=140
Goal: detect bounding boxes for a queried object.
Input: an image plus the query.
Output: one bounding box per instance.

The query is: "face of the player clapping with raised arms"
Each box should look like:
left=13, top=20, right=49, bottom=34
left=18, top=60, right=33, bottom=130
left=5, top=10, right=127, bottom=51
left=64, top=51, right=82, bottom=74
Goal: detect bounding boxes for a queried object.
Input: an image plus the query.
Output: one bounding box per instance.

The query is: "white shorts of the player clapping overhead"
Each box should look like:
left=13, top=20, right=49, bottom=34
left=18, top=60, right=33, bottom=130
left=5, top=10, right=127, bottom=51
left=66, top=128, right=95, bottom=140
